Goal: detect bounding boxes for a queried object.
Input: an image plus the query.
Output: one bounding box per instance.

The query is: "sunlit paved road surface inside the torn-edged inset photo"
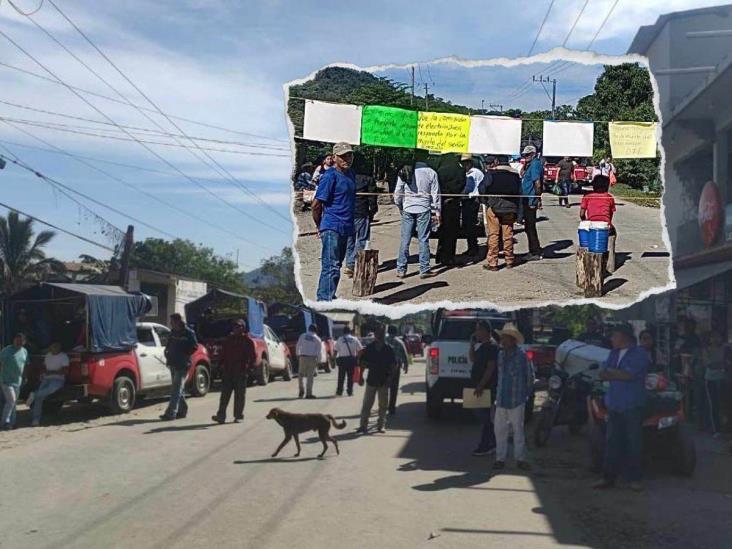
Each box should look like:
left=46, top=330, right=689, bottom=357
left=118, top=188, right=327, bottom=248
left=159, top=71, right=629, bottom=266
left=297, top=195, right=670, bottom=306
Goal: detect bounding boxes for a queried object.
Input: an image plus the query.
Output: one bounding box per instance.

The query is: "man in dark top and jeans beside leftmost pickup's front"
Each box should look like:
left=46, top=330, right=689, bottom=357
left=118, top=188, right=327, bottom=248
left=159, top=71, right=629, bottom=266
left=160, top=313, right=198, bottom=421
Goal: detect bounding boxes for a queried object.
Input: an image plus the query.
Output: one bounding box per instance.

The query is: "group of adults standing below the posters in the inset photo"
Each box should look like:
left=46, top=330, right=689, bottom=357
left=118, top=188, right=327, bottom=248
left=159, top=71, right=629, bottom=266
left=308, top=139, right=556, bottom=301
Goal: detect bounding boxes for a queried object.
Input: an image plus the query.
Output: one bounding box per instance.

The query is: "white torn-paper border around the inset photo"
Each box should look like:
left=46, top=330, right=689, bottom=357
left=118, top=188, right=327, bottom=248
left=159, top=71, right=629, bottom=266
left=283, top=47, right=676, bottom=319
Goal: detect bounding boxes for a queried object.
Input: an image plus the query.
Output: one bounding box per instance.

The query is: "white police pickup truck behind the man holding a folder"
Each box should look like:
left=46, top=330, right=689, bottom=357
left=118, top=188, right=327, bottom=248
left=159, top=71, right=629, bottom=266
left=425, top=309, right=533, bottom=419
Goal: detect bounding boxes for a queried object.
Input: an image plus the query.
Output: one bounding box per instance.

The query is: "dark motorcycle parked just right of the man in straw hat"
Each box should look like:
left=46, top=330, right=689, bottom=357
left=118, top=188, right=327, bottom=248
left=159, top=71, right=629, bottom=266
left=534, top=364, right=600, bottom=447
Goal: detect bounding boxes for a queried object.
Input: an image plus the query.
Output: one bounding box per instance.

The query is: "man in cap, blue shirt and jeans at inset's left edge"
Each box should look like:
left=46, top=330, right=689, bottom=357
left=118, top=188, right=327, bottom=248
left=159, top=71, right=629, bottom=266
left=313, top=143, right=356, bottom=301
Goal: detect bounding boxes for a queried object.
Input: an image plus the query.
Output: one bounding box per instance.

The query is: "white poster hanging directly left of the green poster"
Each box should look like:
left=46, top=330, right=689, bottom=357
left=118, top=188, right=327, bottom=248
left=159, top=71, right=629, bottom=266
left=302, top=100, right=361, bottom=145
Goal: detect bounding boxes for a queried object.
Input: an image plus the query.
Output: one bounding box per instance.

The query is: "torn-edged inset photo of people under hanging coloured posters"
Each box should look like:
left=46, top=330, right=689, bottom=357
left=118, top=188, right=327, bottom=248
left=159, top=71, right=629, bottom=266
left=287, top=57, right=673, bottom=312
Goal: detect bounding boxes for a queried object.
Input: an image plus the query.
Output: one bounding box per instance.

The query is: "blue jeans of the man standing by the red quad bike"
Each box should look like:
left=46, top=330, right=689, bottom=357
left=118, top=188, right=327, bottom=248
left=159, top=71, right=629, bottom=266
left=603, top=406, right=644, bottom=482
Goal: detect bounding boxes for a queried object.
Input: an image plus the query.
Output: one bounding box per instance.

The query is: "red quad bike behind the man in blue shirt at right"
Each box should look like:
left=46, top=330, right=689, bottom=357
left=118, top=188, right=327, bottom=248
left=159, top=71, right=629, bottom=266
left=587, top=374, right=696, bottom=476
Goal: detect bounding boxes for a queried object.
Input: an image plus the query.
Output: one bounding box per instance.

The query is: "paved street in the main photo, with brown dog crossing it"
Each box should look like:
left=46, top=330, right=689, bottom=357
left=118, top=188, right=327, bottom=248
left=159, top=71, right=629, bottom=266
left=0, top=363, right=732, bottom=549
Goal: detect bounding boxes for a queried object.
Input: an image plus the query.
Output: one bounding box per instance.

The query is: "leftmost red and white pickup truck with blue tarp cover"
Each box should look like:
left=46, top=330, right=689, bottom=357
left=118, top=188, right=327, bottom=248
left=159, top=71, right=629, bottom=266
left=4, top=283, right=211, bottom=413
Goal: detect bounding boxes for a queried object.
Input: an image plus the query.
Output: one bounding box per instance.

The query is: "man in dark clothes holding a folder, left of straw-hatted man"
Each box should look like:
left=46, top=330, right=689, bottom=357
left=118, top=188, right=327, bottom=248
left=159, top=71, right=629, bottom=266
left=468, top=320, right=498, bottom=456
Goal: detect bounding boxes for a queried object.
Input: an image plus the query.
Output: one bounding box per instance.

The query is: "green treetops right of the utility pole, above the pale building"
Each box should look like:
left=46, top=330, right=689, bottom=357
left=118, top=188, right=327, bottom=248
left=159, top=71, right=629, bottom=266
left=130, top=238, right=245, bottom=292
